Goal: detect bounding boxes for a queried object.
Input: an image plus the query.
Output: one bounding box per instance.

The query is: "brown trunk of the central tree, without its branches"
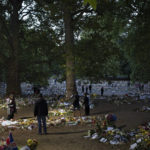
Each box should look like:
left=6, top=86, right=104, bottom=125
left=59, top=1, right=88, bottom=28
left=64, top=6, right=77, bottom=99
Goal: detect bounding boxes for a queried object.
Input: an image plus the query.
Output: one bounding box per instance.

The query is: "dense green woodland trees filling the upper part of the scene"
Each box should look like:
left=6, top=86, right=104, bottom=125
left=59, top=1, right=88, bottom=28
left=0, top=0, right=150, bottom=98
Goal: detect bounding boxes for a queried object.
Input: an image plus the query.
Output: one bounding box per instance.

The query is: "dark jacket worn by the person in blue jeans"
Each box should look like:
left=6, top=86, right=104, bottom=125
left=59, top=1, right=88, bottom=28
left=34, top=98, right=48, bottom=116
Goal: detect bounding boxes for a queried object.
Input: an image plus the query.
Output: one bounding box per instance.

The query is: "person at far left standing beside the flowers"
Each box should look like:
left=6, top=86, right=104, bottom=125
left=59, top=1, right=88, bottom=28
left=6, top=94, right=17, bottom=120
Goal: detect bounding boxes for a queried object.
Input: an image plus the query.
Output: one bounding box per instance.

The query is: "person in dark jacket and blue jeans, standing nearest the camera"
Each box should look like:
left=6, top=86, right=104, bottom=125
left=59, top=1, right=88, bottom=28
left=34, top=94, right=48, bottom=135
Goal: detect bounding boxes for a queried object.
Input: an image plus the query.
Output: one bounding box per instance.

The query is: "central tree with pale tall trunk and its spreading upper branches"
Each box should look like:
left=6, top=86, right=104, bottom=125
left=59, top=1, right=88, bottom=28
left=34, top=0, right=94, bottom=99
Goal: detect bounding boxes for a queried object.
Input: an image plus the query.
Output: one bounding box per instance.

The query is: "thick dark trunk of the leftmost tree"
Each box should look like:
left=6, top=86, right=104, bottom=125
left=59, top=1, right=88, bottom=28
left=6, top=0, right=23, bottom=95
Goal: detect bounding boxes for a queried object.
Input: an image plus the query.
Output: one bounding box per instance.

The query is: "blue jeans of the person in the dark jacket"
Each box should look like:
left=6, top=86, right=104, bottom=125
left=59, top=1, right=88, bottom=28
left=37, top=116, right=47, bottom=134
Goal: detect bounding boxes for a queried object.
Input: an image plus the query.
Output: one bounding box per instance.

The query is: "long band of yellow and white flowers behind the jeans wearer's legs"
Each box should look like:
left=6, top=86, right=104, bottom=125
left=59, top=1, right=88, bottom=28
left=0, top=110, right=92, bottom=133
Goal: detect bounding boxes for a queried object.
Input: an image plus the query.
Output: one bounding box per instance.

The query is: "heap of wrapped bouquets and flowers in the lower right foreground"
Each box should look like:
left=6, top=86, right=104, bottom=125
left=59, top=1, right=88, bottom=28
left=84, top=114, right=150, bottom=150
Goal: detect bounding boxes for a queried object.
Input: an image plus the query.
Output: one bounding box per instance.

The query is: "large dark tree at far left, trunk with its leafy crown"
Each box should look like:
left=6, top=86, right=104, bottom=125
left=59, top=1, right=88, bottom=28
left=0, top=0, right=58, bottom=94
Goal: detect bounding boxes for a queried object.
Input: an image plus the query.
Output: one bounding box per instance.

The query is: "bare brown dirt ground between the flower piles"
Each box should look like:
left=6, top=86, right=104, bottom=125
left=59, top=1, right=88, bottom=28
left=0, top=100, right=150, bottom=150
